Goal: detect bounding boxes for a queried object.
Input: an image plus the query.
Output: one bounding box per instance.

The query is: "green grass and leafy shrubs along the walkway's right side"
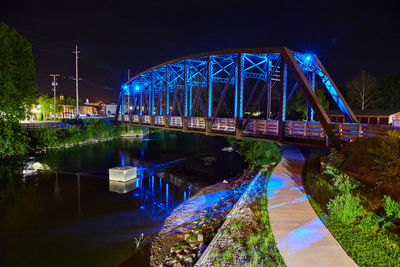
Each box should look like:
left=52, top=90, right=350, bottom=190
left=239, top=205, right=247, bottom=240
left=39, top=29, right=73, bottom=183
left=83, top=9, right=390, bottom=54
left=303, top=152, right=400, bottom=266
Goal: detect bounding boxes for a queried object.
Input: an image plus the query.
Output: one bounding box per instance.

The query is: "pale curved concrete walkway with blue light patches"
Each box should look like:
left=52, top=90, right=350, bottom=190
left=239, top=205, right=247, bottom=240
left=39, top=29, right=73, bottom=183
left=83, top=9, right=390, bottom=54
left=268, top=146, right=357, bottom=267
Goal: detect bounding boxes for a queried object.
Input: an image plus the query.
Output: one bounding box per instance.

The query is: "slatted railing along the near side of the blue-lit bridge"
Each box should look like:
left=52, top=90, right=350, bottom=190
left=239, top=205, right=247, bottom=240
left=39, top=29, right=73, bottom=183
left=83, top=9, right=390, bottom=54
left=119, top=115, right=398, bottom=146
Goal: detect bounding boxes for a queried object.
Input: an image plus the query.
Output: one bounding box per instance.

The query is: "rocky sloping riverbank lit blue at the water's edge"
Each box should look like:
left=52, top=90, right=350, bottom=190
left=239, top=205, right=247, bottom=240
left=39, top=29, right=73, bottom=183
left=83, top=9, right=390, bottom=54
left=150, top=172, right=253, bottom=266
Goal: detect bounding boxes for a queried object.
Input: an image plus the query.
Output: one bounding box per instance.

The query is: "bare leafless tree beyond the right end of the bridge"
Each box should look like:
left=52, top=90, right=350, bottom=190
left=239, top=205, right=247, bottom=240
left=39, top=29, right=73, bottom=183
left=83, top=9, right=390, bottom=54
left=346, top=70, right=379, bottom=110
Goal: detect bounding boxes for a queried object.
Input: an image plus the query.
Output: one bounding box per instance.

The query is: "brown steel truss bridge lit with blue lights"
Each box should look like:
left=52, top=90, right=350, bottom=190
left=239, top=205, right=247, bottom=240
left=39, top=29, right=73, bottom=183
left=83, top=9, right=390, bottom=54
left=116, top=47, right=396, bottom=149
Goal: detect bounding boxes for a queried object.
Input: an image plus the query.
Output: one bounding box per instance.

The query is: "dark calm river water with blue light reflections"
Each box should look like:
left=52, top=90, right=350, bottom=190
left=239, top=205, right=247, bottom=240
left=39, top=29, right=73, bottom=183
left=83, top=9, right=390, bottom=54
left=0, top=132, right=243, bottom=266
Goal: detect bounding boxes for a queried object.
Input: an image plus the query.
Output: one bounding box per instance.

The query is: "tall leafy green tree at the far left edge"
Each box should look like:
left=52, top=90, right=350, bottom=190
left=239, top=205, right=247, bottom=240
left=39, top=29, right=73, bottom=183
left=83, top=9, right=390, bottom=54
left=0, top=23, right=38, bottom=154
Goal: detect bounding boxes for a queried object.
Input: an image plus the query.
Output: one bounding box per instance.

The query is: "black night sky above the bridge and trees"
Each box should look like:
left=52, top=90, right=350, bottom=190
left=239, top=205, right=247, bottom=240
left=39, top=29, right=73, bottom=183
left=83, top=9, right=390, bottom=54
left=0, top=0, right=400, bottom=102
